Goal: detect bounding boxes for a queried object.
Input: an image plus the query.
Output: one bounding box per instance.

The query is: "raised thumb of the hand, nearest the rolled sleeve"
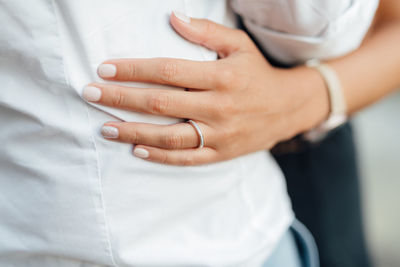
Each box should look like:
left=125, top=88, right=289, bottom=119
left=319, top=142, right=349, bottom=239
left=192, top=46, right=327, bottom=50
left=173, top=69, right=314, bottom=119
left=170, top=11, right=248, bottom=58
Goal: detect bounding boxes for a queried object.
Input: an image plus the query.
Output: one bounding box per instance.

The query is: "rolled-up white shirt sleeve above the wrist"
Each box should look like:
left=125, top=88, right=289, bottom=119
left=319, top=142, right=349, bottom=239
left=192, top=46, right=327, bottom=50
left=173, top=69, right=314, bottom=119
left=230, top=0, right=379, bottom=64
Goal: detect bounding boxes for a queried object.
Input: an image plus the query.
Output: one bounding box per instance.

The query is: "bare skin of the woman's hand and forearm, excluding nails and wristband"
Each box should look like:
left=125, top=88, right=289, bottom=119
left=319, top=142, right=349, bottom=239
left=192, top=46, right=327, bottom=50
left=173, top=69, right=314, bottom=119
left=83, top=0, right=400, bottom=165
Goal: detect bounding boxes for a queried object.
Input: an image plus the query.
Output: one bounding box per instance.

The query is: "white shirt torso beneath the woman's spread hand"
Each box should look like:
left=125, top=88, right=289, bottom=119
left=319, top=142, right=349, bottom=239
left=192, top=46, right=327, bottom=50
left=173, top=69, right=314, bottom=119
left=0, top=0, right=293, bottom=267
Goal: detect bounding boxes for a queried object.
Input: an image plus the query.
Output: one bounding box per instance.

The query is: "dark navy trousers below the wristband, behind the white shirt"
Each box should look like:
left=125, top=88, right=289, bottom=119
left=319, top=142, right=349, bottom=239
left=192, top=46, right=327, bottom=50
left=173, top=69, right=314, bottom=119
left=275, top=124, right=371, bottom=267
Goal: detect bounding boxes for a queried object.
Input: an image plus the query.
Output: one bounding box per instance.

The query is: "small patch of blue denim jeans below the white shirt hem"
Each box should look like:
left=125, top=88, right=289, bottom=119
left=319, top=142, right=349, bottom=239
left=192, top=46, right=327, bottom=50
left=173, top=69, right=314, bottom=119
left=262, top=220, right=319, bottom=267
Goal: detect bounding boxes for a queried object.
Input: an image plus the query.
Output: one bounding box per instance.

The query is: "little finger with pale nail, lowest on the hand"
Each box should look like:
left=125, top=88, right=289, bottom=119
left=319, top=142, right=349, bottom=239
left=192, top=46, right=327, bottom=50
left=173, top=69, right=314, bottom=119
left=133, top=145, right=219, bottom=166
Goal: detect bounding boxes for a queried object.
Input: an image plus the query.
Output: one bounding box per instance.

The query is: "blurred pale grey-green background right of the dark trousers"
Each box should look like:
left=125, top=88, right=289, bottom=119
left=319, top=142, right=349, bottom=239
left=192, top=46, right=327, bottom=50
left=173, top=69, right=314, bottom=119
left=353, top=92, right=400, bottom=267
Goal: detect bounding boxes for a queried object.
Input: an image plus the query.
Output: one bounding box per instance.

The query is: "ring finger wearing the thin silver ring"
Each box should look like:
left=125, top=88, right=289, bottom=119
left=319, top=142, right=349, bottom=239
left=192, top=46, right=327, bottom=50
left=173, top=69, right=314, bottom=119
left=101, top=122, right=212, bottom=149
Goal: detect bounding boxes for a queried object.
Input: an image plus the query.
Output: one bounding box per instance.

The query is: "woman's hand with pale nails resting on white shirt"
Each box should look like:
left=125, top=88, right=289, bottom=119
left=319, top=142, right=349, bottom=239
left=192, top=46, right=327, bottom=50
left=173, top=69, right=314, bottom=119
left=83, top=14, right=328, bottom=165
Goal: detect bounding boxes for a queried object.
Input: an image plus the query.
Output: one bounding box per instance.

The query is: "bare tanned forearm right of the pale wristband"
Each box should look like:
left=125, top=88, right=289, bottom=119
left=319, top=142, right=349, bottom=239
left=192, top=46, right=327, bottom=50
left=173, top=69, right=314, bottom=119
left=328, top=20, right=400, bottom=115
